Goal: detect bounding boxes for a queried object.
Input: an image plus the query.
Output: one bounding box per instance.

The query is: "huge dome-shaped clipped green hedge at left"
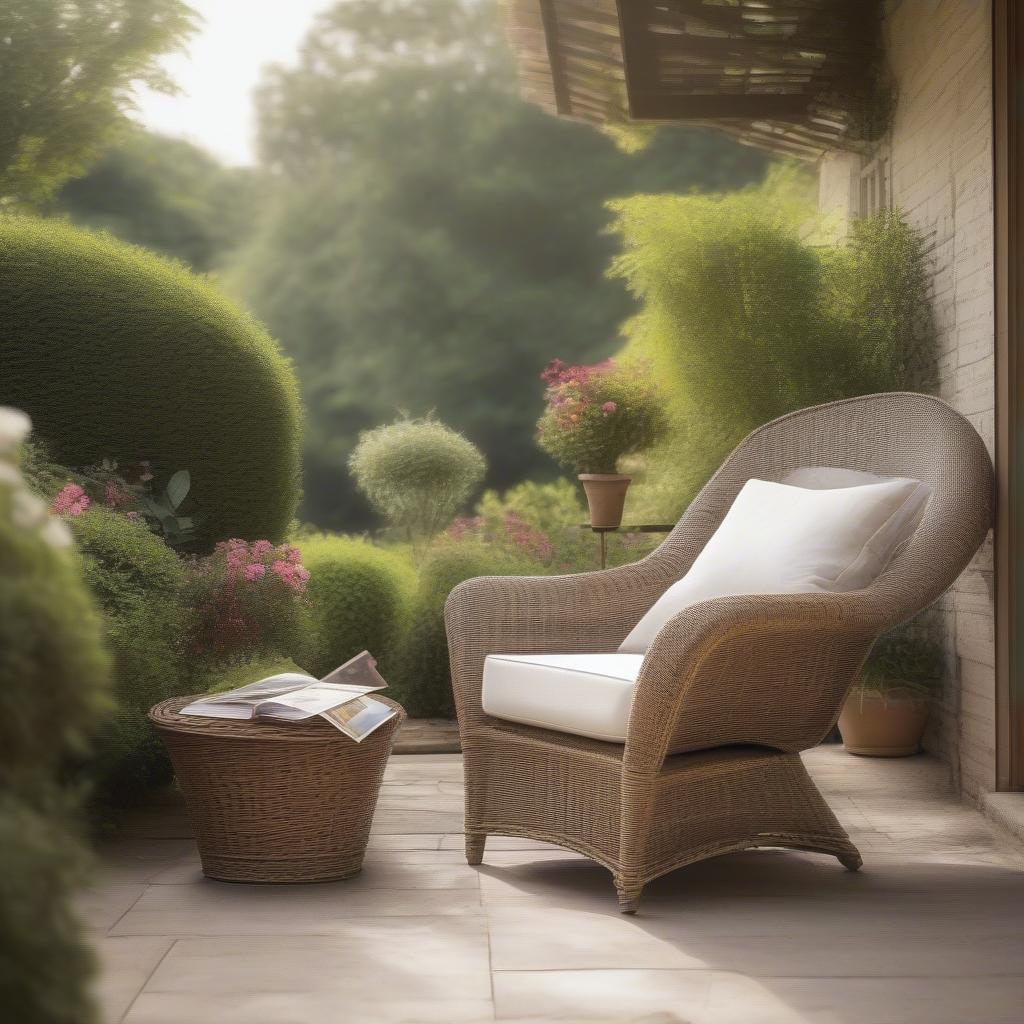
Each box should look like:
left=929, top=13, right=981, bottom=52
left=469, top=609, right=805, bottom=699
left=0, top=217, right=300, bottom=547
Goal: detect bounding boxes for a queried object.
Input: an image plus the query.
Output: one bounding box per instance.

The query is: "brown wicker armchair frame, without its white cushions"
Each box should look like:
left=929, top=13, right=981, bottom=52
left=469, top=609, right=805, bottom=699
left=445, top=393, right=992, bottom=912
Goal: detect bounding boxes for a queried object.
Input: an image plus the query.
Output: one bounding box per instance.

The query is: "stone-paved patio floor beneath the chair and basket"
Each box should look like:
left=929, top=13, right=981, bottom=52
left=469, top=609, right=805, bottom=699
left=82, top=746, right=1024, bottom=1024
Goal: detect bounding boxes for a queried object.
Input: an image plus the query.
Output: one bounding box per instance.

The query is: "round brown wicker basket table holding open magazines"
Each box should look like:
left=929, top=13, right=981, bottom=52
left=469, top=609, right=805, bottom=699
left=150, top=694, right=406, bottom=883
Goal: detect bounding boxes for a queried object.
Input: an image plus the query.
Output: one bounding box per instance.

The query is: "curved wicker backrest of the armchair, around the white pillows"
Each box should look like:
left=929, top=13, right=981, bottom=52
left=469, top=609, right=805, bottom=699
left=651, top=392, right=993, bottom=626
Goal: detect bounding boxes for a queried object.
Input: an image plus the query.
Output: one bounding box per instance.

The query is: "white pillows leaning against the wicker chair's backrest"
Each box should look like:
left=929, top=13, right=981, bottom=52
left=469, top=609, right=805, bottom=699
left=618, top=467, right=932, bottom=653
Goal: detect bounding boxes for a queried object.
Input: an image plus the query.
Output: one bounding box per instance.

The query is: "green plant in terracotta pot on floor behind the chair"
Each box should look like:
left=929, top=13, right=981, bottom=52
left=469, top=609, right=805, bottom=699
left=839, top=631, right=943, bottom=758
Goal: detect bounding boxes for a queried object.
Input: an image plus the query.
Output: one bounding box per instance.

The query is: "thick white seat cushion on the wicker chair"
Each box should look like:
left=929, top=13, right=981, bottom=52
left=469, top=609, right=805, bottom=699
left=483, top=653, right=643, bottom=743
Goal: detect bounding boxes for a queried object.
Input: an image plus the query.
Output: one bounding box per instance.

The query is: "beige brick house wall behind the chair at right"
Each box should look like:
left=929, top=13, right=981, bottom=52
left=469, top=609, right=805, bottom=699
left=819, top=0, right=995, bottom=799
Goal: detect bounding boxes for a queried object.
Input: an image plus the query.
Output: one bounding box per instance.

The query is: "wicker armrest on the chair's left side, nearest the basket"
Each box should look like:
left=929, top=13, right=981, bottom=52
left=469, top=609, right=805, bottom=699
left=444, top=559, right=671, bottom=737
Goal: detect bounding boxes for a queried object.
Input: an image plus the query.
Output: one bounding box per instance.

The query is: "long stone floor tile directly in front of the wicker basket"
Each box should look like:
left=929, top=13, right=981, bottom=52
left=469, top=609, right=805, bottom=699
left=112, top=880, right=481, bottom=936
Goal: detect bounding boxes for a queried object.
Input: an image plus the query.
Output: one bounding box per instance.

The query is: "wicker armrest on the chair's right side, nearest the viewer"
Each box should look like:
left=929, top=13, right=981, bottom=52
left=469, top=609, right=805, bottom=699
left=625, top=591, right=894, bottom=772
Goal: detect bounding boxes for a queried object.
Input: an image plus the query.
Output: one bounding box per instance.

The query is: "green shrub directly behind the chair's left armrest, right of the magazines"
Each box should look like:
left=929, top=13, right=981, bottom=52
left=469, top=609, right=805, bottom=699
left=389, top=538, right=543, bottom=718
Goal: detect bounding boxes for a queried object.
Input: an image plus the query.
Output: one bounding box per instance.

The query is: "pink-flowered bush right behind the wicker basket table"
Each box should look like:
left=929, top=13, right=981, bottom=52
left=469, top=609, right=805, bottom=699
left=188, top=540, right=309, bottom=662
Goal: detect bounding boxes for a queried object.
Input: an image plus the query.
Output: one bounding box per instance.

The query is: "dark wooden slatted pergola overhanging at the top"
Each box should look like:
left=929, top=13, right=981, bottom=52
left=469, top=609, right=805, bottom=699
left=502, top=0, right=881, bottom=160
